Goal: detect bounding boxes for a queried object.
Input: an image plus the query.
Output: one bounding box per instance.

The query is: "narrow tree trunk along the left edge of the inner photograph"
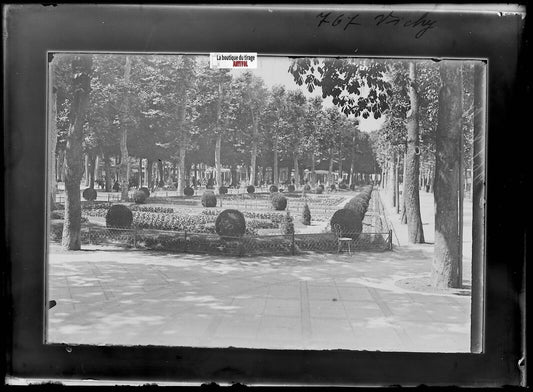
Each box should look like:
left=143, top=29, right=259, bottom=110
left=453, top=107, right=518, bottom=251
left=48, top=58, right=57, bottom=211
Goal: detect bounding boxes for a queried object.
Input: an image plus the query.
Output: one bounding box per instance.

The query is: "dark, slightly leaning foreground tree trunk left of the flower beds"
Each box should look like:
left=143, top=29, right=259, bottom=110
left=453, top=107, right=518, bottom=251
left=62, top=55, right=92, bottom=250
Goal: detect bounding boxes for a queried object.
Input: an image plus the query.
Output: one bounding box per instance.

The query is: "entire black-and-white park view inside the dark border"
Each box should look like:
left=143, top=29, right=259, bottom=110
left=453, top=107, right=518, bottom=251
left=46, top=53, right=485, bottom=352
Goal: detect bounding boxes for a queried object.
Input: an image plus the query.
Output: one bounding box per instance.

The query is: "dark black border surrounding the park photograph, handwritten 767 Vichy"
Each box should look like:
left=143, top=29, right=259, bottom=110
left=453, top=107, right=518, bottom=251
left=3, top=5, right=527, bottom=386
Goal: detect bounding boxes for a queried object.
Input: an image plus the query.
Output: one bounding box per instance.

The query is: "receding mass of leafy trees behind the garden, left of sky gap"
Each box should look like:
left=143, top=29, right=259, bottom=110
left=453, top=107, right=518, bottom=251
left=49, top=54, right=375, bottom=249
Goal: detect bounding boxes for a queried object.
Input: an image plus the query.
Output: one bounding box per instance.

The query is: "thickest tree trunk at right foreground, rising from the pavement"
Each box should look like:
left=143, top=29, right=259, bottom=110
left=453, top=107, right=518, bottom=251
left=431, top=61, right=463, bottom=288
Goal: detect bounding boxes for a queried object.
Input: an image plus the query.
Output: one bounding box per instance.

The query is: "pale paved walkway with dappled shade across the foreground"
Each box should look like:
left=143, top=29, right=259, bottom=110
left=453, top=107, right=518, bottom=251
left=48, top=187, right=470, bottom=352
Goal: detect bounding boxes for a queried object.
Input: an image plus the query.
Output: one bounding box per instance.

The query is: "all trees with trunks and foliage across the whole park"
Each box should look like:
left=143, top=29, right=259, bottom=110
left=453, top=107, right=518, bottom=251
left=49, top=55, right=484, bottom=287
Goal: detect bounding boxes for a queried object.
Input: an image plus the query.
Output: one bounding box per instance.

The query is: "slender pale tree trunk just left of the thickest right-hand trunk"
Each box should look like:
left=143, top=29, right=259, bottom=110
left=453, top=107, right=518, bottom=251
left=403, top=62, right=424, bottom=244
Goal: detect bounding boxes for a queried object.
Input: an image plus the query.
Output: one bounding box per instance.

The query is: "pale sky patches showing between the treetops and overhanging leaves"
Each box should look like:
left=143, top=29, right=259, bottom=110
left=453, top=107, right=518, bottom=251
left=231, top=56, right=385, bottom=132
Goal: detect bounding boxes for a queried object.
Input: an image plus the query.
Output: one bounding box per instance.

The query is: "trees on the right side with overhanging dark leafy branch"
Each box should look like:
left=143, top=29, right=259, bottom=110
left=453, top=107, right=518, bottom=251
left=291, top=59, right=486, bottom=287
